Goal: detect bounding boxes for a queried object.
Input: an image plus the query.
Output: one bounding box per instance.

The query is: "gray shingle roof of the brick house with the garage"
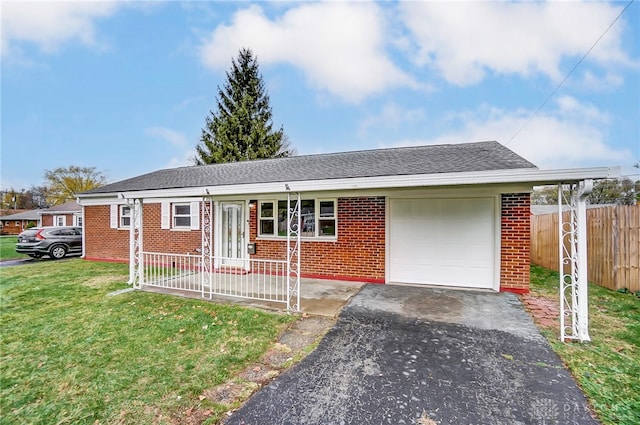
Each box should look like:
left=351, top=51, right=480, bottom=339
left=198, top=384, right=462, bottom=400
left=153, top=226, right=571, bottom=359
left=83, top=142, right=536, bottom=194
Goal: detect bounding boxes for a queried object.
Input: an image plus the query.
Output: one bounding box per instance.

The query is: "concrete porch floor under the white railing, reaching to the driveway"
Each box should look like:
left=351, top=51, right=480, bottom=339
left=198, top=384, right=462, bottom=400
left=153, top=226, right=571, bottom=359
left=142, top=278, right=366, bottom=317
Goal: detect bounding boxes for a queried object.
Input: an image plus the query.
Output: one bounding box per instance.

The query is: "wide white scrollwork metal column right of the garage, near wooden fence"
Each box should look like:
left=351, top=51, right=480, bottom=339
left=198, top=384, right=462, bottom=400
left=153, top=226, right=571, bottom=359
left=558, top=180, right=593, bottom=342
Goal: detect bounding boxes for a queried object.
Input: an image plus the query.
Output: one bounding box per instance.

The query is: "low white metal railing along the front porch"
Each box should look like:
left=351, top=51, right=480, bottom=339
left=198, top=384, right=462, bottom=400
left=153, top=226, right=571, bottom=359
left=140, top=252, right=291, bottom=306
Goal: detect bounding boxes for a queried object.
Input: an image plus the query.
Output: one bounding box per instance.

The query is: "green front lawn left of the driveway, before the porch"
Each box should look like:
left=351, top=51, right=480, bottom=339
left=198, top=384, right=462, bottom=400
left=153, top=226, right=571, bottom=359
left=0, top=259, right=295, bottom=424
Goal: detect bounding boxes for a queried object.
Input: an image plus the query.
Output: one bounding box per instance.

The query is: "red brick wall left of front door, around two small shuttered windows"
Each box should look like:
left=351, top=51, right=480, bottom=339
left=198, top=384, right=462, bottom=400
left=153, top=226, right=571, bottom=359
left=84, top=204, right=202, bottom=261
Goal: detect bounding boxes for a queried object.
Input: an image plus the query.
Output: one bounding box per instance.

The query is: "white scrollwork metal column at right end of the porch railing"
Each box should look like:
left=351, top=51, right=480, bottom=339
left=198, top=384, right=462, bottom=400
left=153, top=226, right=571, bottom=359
left=287, top=193, right=302, bottom=311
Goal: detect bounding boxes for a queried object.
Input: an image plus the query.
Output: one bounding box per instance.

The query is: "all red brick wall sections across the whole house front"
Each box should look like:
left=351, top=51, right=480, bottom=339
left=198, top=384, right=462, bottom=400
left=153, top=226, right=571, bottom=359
left=85, top=193, right=530, bottom=292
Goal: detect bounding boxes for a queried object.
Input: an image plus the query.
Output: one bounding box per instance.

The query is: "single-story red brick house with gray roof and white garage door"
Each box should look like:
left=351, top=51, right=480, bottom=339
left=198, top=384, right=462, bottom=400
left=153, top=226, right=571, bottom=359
left=78, top=142, right=617, bottom=292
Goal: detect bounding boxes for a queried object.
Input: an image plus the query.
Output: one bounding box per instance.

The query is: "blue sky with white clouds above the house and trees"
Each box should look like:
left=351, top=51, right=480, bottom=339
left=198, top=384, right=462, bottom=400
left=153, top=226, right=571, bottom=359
left=0, top=1, right=640, bottom=190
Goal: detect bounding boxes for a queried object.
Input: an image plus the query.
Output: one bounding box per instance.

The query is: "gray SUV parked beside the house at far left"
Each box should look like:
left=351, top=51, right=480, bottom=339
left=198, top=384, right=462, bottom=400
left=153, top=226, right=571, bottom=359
left=16, top=226, right=82, bottom=260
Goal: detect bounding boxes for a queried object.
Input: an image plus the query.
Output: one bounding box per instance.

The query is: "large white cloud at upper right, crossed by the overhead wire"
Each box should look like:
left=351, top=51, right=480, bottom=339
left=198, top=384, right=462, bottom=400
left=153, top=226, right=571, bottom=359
left=400, top=2, right=634, bottom=86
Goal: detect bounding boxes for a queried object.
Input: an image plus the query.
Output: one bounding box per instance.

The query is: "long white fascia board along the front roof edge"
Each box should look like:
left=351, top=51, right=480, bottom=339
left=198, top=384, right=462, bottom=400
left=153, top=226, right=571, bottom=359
left=79, top=167, right=620, bottom=200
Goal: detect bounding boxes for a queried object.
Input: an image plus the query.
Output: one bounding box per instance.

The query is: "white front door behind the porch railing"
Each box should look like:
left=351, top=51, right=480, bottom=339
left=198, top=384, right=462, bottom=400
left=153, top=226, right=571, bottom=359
left=220, top=202, right=245, bottom=267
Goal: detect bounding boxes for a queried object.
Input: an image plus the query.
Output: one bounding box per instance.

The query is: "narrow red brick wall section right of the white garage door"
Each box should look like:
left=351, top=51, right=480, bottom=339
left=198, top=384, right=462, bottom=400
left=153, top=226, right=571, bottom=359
left=500, top=193, right=531, bottom=293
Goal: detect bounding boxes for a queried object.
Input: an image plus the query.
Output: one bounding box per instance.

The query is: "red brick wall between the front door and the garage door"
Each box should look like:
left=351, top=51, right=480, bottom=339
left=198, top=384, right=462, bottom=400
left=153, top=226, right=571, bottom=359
left=249, top=197, right=385, bottom=283
